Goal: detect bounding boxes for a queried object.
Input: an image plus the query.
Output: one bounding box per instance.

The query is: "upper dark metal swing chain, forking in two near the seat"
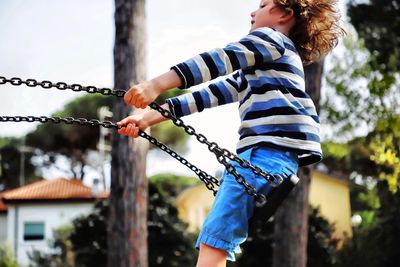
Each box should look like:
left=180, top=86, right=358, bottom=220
left=0, top=76, right=283, bottom=205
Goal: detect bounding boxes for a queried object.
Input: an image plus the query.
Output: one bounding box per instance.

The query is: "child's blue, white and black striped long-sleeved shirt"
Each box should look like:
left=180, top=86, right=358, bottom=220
left=166, top=27, right=322, bottom=166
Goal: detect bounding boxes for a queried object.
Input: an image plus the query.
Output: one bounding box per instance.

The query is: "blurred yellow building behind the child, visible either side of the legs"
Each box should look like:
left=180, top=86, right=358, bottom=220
left=176, top=171, right=352, bottom=239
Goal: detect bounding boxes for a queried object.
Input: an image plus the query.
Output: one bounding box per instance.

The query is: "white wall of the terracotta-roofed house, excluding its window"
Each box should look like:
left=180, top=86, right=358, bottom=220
left=7, top=203, right=93, bottom=266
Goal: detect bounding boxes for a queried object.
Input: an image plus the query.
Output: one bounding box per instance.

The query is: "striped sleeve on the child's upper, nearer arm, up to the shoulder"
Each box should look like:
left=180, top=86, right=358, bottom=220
left=171, top=27, right=285, bottom=89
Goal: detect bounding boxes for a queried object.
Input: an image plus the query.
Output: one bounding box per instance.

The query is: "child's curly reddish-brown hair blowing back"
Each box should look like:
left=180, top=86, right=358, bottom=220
left=274, top=0, right=346, bottom=64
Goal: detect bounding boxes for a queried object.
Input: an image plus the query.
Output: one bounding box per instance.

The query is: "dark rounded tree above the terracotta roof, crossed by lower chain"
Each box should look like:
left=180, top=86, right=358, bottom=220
left=26, top=95, right=111, bottom=180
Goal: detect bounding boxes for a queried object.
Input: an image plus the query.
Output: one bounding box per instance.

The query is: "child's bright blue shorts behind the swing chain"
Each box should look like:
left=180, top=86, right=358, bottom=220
left=196, top=147, right=298, bottom=261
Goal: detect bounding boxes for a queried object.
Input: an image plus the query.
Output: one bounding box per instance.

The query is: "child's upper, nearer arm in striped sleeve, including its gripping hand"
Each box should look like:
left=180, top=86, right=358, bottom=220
left=124, top=28, right=285, bottom=108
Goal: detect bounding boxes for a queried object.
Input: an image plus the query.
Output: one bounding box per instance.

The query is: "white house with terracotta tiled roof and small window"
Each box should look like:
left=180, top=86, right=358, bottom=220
left=0, top=178, right=108, bottom=266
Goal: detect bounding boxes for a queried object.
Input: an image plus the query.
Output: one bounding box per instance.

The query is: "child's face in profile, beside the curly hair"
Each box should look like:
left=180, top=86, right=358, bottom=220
left=250, top=0, right=284, bottom=30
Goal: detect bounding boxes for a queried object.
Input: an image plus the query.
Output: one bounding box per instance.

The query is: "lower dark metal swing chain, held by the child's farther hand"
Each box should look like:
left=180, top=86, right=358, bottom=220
left=0, top=116, right=219, bottom=196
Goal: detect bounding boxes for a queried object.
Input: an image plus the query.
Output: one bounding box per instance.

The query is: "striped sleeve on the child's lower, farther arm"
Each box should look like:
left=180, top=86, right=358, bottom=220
left=166, top=73, right=240, bottom=117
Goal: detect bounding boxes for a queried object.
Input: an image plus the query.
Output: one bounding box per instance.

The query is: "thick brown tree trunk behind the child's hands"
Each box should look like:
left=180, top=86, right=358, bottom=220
left=108, top=0, right=148, bottom=267
